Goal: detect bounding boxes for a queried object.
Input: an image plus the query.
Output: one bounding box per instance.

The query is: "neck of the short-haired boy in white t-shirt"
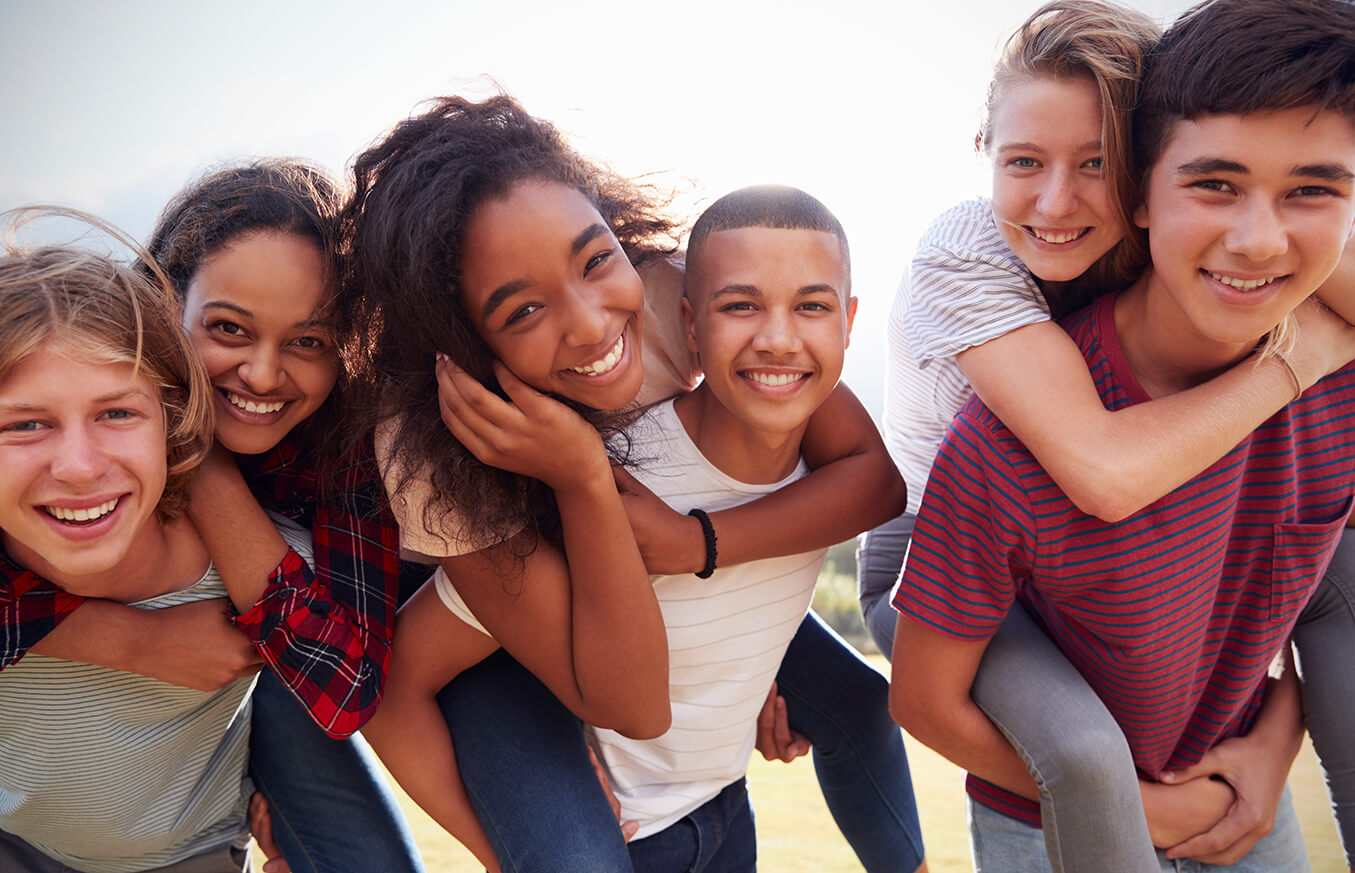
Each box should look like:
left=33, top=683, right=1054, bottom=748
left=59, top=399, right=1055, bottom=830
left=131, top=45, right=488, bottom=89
left=673, top=384, right=806, bottom=484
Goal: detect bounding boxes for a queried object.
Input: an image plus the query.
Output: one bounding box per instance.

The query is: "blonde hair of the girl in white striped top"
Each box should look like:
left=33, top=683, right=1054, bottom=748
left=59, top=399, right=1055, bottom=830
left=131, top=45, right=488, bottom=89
left=974, top=0, right=1161, bottom=314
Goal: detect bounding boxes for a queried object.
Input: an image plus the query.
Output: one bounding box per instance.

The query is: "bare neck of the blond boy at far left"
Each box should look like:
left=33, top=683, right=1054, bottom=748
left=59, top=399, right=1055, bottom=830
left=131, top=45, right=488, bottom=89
left=4, top=516, right=209, bottom=603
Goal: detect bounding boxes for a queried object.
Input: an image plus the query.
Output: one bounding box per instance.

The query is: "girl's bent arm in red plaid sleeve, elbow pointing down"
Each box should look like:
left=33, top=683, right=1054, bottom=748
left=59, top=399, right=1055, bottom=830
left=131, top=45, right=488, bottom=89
left=188, top=447, right=400, bottom=737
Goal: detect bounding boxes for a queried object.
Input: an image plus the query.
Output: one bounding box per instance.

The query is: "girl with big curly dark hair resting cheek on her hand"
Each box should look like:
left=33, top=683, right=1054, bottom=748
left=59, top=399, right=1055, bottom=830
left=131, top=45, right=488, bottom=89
left=346, top=96, right=920, bottom=870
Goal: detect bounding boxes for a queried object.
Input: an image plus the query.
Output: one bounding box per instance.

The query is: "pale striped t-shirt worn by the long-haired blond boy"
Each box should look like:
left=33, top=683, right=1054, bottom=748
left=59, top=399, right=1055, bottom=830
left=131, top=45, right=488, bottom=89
left=0, top=523, right=310, bottom=873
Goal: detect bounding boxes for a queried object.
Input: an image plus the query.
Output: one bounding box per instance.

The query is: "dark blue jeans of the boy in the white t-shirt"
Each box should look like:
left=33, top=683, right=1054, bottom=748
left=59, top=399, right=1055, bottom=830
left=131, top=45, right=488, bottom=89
left=629, top=779, right=757, bottom=873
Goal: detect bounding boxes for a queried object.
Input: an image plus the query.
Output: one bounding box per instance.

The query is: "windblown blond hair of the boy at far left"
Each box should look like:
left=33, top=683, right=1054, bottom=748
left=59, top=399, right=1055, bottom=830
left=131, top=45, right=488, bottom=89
left=0, top=207, right=213, bottom=521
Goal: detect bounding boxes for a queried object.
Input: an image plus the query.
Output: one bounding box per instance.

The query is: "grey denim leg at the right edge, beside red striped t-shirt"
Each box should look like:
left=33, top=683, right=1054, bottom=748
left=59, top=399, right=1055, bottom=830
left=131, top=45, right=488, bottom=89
left=1294, top=535, right=1355, bottom=868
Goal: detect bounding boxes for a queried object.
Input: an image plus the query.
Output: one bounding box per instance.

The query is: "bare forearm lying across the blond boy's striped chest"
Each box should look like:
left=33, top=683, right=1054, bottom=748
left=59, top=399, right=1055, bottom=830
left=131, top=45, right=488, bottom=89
left=31, top=599, right=263, bottom=691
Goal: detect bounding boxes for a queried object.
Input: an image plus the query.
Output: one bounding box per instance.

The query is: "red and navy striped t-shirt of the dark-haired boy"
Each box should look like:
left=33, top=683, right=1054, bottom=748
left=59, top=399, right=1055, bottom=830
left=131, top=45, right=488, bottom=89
left=894, top=296, right=1355, bottom=824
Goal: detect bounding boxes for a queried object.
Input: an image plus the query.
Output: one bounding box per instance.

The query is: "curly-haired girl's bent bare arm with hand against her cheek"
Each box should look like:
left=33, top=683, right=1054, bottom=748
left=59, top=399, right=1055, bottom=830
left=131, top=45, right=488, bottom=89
left=439, top=363, right=671, bottom=737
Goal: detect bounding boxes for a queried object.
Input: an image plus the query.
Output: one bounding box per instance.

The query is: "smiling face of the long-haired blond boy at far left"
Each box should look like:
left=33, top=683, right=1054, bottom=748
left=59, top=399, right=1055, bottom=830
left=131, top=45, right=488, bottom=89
left=0, top=340, right=167, bottom=595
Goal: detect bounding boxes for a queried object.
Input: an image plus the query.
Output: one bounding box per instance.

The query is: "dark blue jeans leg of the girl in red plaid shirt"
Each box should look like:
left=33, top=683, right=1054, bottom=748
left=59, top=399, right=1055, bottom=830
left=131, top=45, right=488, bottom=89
left=249, top=670, right=424, bottom=873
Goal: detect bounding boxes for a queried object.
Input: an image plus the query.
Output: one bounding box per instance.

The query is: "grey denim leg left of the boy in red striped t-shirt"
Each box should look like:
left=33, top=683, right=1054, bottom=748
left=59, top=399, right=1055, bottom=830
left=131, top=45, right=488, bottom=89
left=970, top=605, right=1157, bottom=873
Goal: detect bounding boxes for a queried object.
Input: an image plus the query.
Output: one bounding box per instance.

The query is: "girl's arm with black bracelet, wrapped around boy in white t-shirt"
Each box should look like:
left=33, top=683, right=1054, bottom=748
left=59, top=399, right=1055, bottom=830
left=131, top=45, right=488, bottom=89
left=618, top=384, right=908, bottom=573
